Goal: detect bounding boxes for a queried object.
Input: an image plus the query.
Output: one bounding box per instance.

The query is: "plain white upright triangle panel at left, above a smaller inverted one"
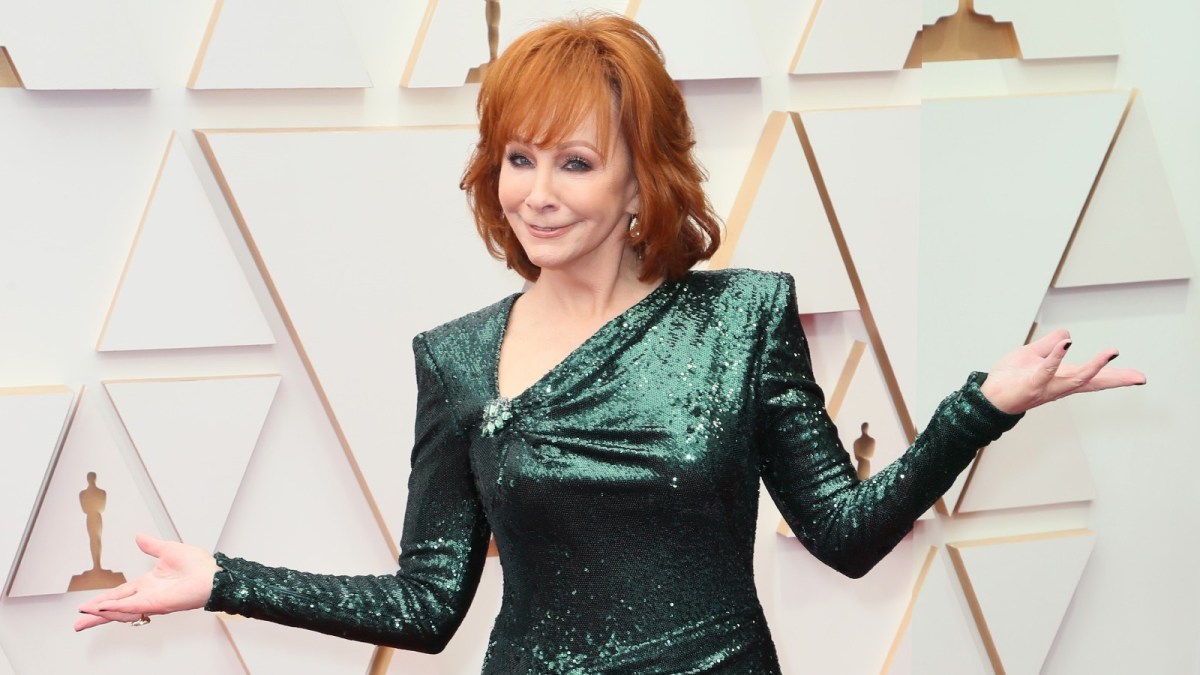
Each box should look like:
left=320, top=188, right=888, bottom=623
left=97, top=136, right=275, bottom=352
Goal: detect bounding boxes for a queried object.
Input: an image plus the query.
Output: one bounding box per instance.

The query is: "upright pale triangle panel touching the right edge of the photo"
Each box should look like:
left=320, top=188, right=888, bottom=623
left=1055, top=92, right=1194, bottom=288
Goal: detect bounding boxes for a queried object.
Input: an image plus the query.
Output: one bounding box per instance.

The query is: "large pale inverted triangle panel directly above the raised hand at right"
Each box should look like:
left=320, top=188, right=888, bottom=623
left=910, top=91, right=1128, bottom=425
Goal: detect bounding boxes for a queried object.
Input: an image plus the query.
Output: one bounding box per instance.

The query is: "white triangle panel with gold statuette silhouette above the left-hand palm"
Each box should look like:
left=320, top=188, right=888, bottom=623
left=8, top=392, right=157, bottom=597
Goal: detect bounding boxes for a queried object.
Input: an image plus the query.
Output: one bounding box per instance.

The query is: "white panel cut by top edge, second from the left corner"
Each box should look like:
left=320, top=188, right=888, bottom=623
left=187, top=0, right=371, bottom=89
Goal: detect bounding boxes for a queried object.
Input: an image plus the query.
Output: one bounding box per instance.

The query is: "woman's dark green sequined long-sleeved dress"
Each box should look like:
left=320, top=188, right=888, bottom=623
left=208, top=270, right=1018, bottom=675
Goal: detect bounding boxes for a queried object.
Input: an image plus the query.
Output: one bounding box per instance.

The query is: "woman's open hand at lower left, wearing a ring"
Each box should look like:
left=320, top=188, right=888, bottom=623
left=74, top=534, right=221, bottom=631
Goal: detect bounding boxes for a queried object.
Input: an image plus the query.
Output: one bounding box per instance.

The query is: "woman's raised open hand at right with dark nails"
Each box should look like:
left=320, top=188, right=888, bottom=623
left=980, top=328, right=1146, bottom=414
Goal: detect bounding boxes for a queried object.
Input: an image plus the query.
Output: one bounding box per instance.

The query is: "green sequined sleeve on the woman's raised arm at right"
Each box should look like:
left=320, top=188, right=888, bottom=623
left=756, top=270, right=1020, bottom=578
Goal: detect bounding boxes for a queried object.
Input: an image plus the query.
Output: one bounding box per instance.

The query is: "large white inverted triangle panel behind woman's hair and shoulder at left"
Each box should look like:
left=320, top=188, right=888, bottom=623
left=199, top=127, right=520, bottom=548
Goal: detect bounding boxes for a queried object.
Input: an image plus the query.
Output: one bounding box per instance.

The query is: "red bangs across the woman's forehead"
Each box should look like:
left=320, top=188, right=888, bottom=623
left=480, top=28, right=618, bottom=160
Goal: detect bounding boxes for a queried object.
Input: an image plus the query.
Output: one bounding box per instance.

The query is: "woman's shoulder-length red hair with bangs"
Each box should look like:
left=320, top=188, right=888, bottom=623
left=462, top=14, right=721, bottom=281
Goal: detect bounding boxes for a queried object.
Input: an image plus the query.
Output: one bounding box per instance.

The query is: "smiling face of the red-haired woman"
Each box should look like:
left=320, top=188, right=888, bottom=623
left=499, top=114, right=637, bottom=274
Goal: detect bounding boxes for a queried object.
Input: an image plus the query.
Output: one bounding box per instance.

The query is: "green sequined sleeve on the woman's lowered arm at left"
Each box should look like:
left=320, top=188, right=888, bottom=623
left=205, top=335, right=491, bottom=652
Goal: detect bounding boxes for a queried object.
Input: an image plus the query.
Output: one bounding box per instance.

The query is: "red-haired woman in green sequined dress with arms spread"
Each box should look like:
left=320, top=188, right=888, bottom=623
left=76, top=16, right=1145, bottom=674
